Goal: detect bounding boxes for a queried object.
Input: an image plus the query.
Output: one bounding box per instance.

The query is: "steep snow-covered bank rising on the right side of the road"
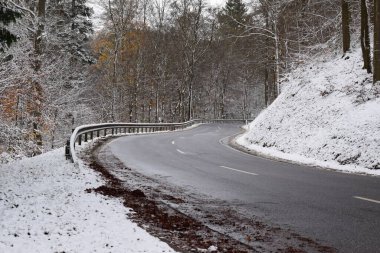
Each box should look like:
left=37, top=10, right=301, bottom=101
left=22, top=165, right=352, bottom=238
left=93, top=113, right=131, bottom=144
left=237, top=49, right=380, bottom=175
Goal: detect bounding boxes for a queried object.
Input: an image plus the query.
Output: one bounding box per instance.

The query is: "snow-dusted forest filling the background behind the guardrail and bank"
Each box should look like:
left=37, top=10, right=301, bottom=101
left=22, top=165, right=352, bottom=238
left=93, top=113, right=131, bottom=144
left=0, top=0, right=380, bottom=163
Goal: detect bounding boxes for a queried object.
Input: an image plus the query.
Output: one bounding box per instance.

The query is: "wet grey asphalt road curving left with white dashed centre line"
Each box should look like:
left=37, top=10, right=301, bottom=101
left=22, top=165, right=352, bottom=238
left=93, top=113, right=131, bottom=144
left=108, top=124, right=380, bottom=253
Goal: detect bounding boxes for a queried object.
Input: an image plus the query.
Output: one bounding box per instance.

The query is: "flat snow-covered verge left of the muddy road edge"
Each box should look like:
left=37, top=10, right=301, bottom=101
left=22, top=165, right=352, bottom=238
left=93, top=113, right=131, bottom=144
left=0, top=148, right=178, bottom=253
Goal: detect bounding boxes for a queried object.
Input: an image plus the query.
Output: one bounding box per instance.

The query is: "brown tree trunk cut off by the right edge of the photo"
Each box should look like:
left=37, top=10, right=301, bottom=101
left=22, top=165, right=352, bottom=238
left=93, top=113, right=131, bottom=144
left=373, top=0, right=380, bottom=84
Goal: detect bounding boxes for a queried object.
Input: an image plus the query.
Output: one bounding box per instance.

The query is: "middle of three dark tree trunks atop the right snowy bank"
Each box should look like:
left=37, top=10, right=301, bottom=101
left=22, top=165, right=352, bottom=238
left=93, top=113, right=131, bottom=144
left=360, top=0, right=372, bottom=73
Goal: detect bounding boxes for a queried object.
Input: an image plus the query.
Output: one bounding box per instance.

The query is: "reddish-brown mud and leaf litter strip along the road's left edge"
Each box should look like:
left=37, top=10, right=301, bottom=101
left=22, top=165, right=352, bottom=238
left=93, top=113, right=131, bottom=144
left=81, top=138, right=336, bottom=253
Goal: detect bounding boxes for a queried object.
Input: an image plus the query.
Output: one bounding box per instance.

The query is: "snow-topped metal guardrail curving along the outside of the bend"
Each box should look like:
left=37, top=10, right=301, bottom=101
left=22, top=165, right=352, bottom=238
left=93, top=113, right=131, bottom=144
left=65, top=119, right=248, bottom=163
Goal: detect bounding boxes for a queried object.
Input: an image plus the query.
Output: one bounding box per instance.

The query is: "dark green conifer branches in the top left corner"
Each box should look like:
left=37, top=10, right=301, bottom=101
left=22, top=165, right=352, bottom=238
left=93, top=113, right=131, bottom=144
left=0, top=1, right=21, bottom=51
